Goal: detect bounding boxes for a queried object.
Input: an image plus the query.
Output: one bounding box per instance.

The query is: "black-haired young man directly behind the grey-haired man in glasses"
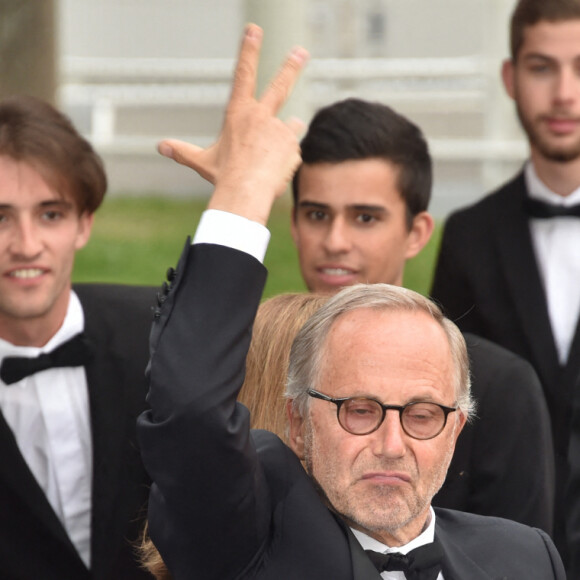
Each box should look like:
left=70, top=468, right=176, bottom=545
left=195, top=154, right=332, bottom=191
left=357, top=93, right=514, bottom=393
left=292, top=99, right=554, bottom=533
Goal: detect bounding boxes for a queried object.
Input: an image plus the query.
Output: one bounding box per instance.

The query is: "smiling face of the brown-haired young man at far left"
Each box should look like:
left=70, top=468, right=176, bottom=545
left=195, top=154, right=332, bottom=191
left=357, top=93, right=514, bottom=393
left=0, top=155, right=93, bottom=346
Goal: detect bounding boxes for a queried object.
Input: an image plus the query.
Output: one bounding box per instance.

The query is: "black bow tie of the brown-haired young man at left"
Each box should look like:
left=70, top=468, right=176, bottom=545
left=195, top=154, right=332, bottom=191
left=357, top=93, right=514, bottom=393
left=0, top=334, right=92, bottom=385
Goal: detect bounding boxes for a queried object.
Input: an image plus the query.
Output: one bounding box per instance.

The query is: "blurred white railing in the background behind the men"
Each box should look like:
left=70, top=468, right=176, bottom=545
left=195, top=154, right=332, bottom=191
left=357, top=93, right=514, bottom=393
left=59, top=57, right=525, bottom=160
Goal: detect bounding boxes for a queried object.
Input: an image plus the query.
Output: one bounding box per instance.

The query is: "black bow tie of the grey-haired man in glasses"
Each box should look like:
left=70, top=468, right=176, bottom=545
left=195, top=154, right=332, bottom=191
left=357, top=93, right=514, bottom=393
left=365, top=541, right=443, bottom=580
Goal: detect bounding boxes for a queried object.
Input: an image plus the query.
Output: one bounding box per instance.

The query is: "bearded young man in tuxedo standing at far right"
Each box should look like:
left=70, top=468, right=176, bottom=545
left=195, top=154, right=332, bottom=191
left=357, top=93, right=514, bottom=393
left=432, top=0, right=580, bottom=550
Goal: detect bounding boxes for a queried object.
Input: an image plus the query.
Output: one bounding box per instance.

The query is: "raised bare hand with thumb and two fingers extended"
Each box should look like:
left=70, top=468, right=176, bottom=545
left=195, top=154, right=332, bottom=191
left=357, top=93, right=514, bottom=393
left=159, top=24, right=308, bottom=224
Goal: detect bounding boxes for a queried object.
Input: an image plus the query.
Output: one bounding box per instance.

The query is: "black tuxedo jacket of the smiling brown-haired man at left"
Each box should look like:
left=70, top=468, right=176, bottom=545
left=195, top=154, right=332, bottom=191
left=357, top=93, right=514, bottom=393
left=0, top=284, right=155, bottom=580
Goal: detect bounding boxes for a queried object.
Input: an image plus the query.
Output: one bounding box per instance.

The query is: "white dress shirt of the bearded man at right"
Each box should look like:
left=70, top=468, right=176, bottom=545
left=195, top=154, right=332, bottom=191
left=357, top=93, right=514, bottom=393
left=524, top=162, right=580, bottom=365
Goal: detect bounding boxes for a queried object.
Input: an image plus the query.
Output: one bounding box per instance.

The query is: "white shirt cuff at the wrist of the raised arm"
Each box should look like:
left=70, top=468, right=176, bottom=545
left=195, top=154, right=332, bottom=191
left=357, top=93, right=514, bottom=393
left=193, top=209, right=270, bottom=262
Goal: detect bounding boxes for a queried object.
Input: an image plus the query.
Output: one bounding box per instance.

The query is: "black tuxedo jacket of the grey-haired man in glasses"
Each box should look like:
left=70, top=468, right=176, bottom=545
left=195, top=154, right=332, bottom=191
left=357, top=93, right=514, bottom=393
left=138, top=244, right=564, bottom=580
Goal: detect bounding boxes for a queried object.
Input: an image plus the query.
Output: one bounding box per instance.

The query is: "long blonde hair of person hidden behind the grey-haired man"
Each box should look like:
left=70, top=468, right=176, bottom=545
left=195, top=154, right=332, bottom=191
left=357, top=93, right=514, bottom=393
left=139, top=294, right=329, bottom=580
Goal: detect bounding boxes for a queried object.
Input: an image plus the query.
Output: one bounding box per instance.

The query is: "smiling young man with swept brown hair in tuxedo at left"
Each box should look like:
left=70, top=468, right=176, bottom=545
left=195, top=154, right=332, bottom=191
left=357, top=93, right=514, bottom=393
left=0, top=97, right=154, bottom=580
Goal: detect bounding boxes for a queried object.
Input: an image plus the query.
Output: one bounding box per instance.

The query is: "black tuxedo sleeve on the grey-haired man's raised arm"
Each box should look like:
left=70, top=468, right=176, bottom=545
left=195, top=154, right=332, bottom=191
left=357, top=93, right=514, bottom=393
left=138, top=244, right=270, bottom=580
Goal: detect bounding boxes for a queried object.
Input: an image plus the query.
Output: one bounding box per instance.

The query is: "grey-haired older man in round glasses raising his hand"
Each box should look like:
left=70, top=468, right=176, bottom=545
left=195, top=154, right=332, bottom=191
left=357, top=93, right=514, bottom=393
left=138, top=25, right=563, bottom=580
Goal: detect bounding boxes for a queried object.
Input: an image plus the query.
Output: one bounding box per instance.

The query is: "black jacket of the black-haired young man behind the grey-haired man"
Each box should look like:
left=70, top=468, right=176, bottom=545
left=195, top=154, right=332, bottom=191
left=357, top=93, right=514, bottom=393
left=433, top=333, right=555, bottom=533
